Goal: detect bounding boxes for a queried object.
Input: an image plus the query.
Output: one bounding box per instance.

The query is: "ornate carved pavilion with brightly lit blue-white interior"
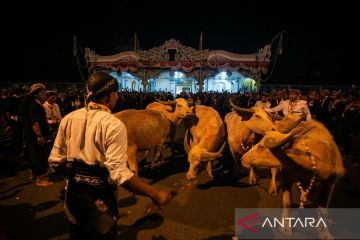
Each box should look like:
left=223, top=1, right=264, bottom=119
left=85, top=39, right=271, bottom=96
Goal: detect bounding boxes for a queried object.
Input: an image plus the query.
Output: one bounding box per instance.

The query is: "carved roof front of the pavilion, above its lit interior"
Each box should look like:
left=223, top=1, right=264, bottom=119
left=85, top=39, right=271, bottom=79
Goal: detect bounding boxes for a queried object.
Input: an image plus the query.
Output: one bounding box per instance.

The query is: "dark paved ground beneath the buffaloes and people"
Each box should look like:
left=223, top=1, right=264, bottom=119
left=0, top=148, right=360, bottom=240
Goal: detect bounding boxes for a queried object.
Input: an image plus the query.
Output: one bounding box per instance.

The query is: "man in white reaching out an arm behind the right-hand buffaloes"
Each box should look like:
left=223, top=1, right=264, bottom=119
left=265, top=89, right=311, bottom=121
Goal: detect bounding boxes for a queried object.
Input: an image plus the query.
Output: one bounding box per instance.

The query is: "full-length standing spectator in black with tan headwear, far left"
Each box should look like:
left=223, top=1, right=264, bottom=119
left=26, top=83, right=53, bottom=187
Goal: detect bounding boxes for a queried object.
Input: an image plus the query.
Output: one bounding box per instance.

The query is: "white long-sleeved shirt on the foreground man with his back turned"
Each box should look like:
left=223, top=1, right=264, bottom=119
left=49, top=108, right=134, bottom=185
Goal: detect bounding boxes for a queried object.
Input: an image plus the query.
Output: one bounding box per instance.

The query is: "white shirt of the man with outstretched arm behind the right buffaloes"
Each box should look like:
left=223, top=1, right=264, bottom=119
left=265, top=100, right=311, bottom=121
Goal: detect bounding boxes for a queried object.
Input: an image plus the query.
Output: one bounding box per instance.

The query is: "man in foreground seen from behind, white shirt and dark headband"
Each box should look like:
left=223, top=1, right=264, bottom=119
left=49, top=72, right=171, bottom=239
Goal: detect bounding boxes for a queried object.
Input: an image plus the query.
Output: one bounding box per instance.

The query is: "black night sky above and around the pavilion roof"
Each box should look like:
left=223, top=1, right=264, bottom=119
left=1, top=0, right=359, bottom=85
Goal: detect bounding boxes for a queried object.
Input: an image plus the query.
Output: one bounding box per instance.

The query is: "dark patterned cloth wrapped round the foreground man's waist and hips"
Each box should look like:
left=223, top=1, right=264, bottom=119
left=65, top=161, right=118, bottom=234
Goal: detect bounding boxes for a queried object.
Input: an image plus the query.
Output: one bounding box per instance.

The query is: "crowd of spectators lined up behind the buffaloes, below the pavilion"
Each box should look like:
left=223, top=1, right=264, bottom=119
left=0, top=82, right=360, bottom=165
